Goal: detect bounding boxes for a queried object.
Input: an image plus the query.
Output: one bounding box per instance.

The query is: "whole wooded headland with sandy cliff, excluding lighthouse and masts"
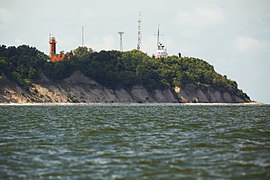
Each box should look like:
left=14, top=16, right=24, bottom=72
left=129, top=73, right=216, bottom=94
left=0, top=45, right=251, bottom=103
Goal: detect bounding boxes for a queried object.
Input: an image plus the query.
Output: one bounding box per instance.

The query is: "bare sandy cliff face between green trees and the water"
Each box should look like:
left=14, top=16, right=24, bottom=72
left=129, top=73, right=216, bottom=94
left=0, top=72, right=249, bottom=103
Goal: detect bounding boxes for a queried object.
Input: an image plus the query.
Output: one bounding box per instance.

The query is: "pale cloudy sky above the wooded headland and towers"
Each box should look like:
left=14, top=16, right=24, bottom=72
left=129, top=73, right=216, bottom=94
left=0, top=0, right=270, bottom=103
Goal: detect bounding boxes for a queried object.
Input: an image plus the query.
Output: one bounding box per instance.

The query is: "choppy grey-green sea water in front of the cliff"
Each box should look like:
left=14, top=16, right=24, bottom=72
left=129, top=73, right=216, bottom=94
left=0, top=105, right=270, bottom=179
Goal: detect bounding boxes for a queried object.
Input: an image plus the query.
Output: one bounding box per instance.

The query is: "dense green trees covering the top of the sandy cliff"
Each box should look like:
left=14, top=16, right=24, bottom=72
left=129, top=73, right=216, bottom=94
left=0, top=45, right=249, bottom=100
